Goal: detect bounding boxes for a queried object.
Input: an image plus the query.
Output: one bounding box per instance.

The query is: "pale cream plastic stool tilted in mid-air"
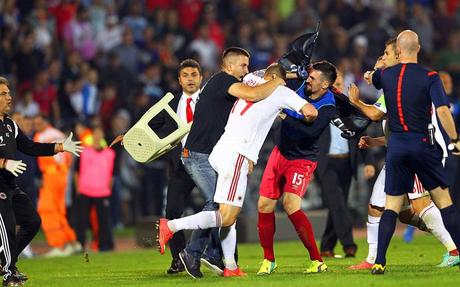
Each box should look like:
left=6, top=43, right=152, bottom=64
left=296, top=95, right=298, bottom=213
left=123, top=93, right=192, bottom=163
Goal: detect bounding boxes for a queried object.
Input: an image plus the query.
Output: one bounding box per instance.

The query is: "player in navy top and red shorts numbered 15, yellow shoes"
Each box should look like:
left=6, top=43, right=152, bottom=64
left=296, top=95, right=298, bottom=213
left=257, top=61, right=337, bottom=275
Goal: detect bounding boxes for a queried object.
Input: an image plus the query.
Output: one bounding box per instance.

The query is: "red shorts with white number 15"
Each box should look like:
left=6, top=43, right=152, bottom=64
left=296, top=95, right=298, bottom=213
left=259, top=146, right=317, bottom=199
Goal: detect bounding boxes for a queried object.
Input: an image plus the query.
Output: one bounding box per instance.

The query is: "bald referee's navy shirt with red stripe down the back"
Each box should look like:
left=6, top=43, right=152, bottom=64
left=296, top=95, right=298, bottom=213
left=372, top=63, right=449, bottom=134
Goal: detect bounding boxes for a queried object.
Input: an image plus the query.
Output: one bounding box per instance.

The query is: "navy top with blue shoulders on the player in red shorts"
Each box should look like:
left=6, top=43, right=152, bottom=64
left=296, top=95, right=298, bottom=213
left=278, top=87, right=336, bottom=161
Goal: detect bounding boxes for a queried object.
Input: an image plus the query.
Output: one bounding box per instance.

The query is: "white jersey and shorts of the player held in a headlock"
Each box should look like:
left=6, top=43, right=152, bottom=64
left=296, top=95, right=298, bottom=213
left=209, top=68, right=317, bottom=207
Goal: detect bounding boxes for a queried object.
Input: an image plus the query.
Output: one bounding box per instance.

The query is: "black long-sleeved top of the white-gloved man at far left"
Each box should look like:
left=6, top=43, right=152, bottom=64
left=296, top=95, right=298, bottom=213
left=0, top=115, right=55, bottom=190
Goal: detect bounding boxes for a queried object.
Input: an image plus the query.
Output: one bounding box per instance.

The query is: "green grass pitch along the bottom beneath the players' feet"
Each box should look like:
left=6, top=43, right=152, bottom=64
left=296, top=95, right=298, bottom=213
left=19, top=235, right=460, bottom=287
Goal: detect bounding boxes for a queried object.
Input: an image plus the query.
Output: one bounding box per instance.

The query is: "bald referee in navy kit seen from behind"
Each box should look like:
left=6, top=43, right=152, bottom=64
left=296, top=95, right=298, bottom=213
left=365, top=30, right=460, bottom=274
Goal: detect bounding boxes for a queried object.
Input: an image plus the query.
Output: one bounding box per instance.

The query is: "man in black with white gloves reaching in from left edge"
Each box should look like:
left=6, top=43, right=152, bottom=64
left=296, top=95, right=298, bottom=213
left=0, top=77, right=82, bottom=286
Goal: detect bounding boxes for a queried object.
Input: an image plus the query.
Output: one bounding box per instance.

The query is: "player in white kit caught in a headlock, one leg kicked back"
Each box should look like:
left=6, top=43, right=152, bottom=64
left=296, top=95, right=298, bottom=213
left=158, top=64, right=318, bottom=276
